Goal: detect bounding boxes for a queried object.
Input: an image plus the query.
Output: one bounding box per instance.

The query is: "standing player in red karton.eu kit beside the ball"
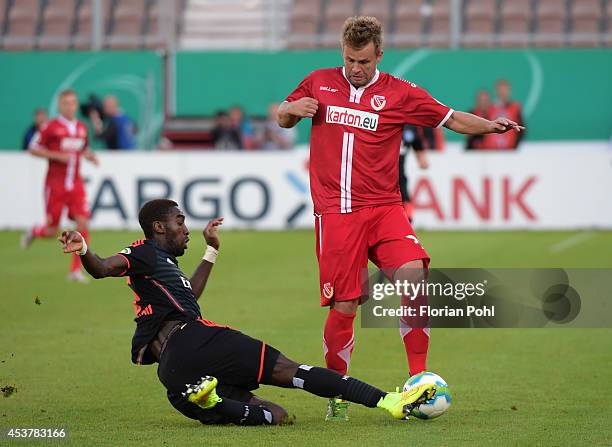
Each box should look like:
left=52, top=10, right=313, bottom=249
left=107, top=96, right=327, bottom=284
left=278, top=17, right=522, bottom=419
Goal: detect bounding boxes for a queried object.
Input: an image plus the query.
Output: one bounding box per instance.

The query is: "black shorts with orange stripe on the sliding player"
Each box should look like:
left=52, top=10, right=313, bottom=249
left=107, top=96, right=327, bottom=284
left=157, top=321, right=280, bottom=400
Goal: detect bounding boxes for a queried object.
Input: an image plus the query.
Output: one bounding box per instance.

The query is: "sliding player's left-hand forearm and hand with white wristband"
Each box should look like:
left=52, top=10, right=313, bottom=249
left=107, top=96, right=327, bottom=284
left=58, top=231, right=129, bottom=279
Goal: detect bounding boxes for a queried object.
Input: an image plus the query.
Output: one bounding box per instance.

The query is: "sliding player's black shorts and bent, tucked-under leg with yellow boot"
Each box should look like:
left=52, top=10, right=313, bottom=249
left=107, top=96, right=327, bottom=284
left=157, top=320, right=287, bottom=425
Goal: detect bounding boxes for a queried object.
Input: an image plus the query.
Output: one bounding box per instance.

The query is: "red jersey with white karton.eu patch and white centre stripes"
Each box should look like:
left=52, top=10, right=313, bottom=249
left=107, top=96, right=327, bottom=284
left=287, top=67, right=453, bottom=214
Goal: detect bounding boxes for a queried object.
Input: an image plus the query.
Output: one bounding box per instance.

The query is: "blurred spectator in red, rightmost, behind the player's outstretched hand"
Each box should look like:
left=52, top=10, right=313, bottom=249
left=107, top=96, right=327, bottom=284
left=483, top=79, right=525, bottom=149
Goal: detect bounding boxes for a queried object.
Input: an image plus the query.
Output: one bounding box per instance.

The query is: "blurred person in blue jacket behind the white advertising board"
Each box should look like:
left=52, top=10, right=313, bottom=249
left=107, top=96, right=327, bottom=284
left=89, top=95, right=136, bottom=149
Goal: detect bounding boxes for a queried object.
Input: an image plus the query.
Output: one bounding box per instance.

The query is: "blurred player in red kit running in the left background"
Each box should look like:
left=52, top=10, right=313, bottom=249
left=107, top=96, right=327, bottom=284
left=22, top=90, right=98, bottom=282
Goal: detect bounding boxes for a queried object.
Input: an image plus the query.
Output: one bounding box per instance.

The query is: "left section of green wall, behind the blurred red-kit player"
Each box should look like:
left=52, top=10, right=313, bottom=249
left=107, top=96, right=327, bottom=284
left=0, top=51, right=163, bottom=149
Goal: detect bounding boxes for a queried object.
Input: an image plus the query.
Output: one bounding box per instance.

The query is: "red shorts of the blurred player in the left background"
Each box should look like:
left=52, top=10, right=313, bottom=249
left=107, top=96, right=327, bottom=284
left=45, top=181, right=91, bottom=227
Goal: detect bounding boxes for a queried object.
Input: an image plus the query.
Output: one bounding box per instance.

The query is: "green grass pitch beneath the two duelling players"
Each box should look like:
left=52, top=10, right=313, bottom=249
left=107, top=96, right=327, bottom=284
left=0, top=231, right=612, bottom=446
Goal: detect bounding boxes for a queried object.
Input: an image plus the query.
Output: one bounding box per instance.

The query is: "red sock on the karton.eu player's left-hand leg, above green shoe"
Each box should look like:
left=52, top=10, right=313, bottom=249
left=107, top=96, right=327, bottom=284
left=323, top=309, right=356, bottom=375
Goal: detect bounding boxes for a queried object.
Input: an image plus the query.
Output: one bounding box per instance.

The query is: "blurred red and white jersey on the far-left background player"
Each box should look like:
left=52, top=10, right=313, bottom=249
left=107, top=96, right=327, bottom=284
left=30, top=116, right=88, bottom=190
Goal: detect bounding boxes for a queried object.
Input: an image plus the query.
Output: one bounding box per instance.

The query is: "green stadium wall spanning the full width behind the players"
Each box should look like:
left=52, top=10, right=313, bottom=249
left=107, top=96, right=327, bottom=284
left=0, top=49, right=612, bottom=148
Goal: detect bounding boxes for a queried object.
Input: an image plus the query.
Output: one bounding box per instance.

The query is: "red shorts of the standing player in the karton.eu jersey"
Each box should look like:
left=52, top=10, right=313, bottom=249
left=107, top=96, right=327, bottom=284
left=315, top=204, right=429, bottom=306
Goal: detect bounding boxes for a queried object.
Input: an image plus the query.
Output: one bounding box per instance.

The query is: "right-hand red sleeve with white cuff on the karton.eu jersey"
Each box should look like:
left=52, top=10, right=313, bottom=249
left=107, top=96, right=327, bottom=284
left=403, top=82, right=454, bottom=127
